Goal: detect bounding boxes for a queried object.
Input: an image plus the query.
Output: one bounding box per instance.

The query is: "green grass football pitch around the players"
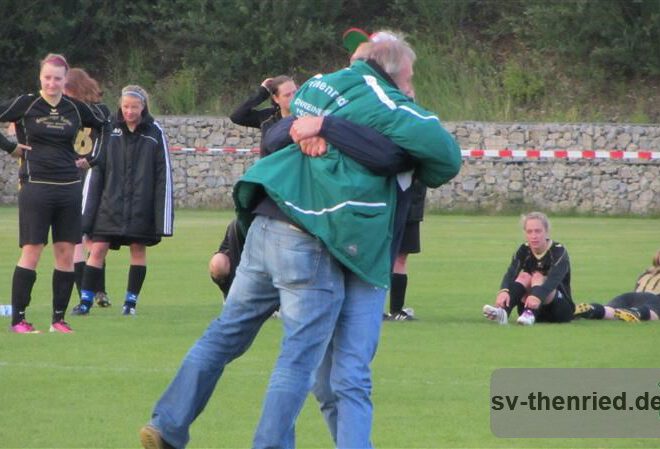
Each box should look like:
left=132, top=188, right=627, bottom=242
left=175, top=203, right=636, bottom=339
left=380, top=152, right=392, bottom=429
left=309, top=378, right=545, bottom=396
left=0, top=208, right=660, bottom=448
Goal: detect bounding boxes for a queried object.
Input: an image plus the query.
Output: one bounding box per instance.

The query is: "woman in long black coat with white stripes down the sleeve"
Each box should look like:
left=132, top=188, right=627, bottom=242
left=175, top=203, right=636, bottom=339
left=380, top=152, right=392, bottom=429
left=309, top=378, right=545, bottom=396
left=71, top=85, right=174, bottom=316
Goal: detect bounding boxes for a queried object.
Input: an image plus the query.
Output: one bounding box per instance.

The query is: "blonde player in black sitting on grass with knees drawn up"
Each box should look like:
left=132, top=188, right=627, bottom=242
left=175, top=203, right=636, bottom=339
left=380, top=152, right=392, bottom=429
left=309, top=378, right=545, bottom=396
left=483, top=212, right=575, bottom=326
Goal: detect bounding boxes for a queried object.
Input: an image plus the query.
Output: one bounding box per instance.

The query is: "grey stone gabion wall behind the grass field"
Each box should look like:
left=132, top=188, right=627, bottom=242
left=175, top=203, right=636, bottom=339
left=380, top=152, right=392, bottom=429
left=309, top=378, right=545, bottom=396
left=0, top=116, right=660, bottom=215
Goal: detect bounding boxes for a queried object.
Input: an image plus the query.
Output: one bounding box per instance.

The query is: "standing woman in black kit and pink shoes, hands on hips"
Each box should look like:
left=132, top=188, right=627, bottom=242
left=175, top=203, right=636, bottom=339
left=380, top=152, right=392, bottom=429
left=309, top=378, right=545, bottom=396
left=0, top=54, right=109, bottom=333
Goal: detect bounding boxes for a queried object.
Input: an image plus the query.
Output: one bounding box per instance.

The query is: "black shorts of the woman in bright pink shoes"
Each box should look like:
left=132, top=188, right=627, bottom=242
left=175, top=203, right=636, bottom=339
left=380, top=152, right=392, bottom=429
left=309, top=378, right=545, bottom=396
left=18, top=182, right=82, bottom=247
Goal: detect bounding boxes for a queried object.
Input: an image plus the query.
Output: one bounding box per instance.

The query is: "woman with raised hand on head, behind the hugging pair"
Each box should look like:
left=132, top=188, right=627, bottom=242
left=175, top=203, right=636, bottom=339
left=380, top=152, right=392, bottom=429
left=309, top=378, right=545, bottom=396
left=209, top=75, right=298, bottom=297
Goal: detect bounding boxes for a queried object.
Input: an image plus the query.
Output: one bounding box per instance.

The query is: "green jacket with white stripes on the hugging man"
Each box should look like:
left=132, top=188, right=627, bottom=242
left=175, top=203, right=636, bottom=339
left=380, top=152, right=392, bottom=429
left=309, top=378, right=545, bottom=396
left=234, top=61, right=461, bottom=287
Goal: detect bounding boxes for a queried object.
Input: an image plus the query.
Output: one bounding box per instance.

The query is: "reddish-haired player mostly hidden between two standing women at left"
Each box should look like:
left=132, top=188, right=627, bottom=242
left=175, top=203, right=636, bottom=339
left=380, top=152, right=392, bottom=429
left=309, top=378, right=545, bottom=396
left=64, top=67, right=110, bottom=308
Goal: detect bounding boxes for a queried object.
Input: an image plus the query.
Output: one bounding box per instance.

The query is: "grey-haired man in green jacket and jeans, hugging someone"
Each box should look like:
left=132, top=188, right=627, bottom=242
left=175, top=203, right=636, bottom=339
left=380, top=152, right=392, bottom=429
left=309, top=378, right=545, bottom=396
left=143, top=32, right=460, bottom=447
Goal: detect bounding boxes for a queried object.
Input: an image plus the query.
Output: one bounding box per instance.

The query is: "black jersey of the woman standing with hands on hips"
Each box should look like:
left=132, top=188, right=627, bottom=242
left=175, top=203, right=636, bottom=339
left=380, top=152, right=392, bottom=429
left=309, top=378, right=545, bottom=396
left=0, top=94, right=109, bottom=184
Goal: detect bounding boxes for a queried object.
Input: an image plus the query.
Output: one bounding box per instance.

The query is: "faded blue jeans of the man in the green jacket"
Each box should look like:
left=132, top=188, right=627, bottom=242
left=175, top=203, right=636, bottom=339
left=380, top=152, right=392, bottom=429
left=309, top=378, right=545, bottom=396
left=151, top=216, right=344, bottom=448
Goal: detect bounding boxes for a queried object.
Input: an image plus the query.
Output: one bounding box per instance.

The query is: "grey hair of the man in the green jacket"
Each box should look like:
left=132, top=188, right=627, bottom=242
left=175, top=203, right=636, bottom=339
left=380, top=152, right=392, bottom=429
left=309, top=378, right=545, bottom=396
left=360, top=30, right=417, bottom=78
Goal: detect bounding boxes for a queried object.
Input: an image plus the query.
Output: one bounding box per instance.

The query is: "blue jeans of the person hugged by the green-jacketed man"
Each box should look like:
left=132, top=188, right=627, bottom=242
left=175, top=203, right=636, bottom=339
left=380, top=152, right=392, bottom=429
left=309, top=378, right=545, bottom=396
left=313, top=273, right=387, bottom=448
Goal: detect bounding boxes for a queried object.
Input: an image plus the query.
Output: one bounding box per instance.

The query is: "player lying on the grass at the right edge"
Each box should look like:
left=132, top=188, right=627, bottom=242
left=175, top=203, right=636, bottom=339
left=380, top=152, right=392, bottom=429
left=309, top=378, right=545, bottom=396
left=574, top=250, right=660, bottom=323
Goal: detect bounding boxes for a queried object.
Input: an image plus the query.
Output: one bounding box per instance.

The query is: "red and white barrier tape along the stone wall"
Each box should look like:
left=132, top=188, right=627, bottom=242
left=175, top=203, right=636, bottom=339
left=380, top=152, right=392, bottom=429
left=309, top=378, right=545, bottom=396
left=170, top=146, right=660, bottom=160
